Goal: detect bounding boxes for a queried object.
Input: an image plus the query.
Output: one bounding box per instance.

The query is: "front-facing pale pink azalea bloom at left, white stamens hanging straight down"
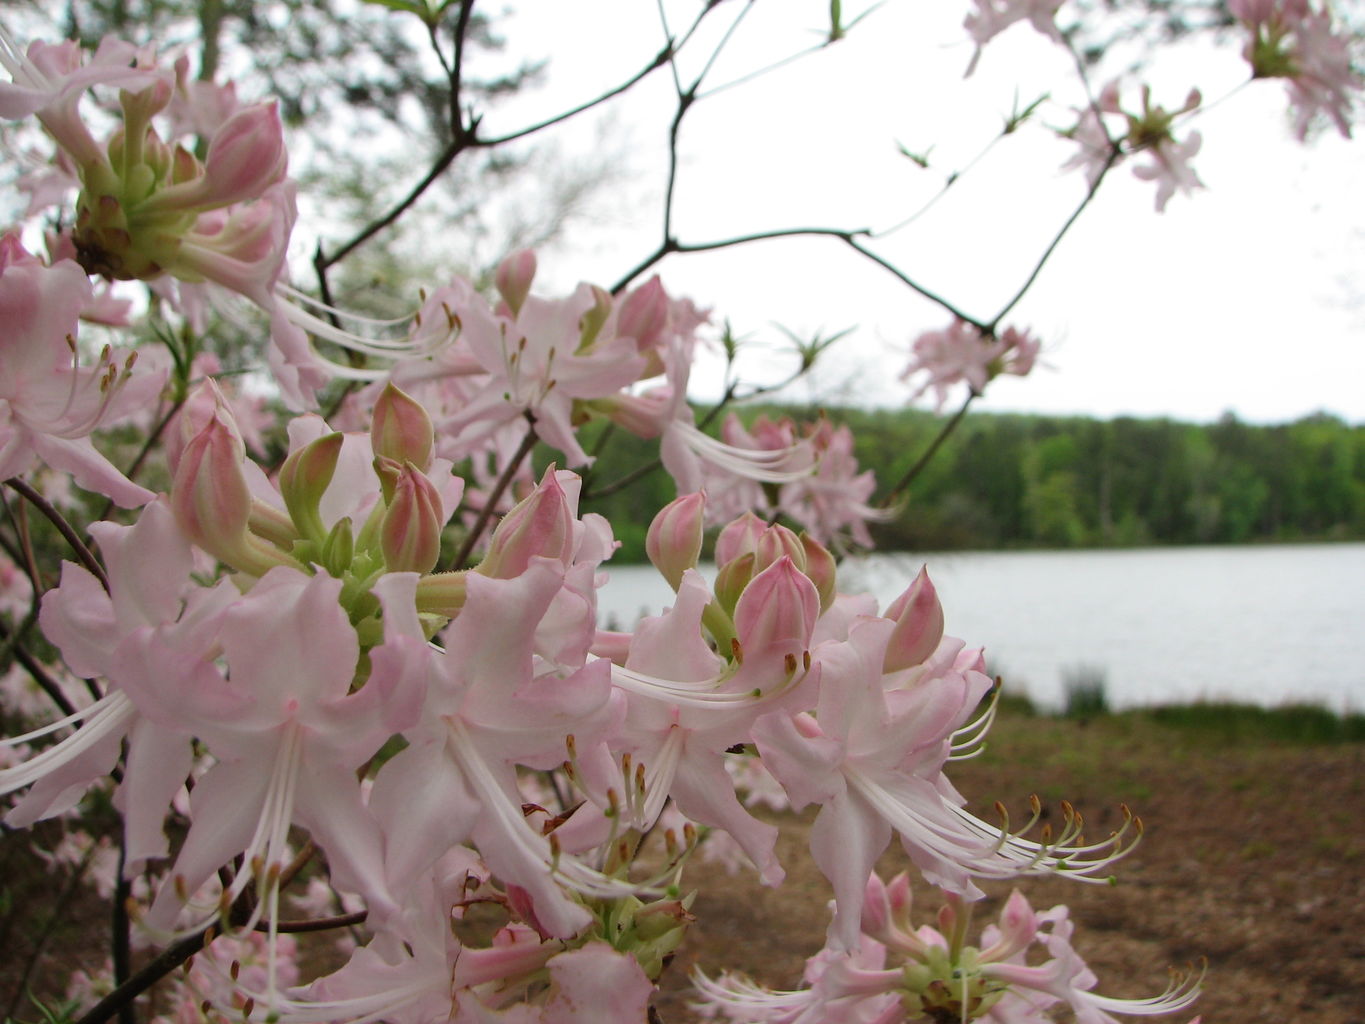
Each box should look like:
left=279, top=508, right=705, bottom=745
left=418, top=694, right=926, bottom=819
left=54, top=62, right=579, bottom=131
left=126, top=567, right=420, bottom=928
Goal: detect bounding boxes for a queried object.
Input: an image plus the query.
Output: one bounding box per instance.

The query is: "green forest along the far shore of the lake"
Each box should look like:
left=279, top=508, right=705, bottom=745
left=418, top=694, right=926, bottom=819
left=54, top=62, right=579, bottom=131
left=570, top=406, right=1365, bottom=561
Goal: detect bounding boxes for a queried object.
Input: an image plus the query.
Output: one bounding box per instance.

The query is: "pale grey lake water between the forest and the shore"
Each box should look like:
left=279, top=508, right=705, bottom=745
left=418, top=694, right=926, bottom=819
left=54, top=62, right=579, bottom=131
left=599, top=543, right=1365, bottom=711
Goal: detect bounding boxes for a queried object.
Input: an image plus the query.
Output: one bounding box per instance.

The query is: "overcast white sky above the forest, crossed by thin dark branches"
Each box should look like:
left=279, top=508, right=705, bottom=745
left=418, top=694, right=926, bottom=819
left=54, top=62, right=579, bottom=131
left=485, top=0, right=1365, bottom=422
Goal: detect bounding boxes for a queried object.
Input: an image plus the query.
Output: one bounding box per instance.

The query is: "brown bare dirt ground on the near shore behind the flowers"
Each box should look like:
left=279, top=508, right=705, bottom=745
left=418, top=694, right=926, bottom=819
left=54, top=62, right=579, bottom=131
left=0, top=714, right=1365, bottom=1024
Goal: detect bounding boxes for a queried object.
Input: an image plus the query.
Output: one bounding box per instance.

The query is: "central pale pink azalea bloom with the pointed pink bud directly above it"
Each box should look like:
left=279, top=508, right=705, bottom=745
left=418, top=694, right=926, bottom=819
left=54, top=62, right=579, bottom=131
left=373, top=474, right=633, bottom=938
